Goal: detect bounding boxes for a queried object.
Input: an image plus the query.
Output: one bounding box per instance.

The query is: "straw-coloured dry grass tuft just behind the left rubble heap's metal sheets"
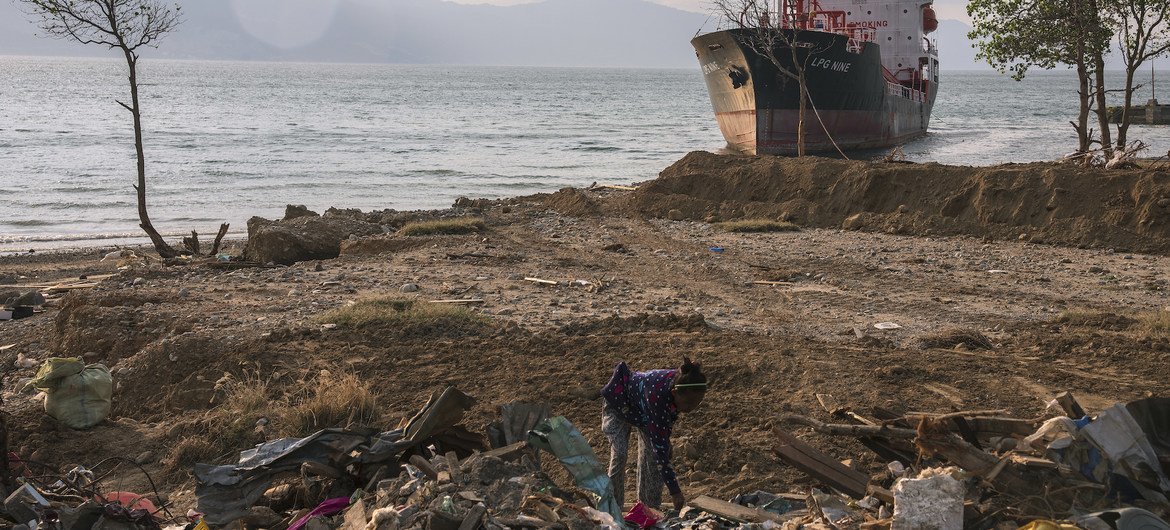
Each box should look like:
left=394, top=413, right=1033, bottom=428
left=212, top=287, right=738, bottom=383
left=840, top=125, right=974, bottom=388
left=275, top=372, right=380, bottom=438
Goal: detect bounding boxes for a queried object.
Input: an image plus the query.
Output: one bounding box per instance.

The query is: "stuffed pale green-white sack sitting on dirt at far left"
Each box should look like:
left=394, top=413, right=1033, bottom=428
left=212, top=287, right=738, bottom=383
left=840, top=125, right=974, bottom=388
left=29, top=358, right=113, bottom=429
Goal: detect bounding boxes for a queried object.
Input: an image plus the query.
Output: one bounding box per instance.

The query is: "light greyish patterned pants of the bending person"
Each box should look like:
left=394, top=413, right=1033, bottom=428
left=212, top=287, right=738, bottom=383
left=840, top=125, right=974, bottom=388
left=601, top=407, right=662, bottom=509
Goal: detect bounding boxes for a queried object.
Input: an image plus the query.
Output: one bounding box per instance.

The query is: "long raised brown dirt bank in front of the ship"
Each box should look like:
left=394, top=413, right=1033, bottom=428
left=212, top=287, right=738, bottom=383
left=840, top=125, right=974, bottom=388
left=629, top=152, right=1170, bottom=254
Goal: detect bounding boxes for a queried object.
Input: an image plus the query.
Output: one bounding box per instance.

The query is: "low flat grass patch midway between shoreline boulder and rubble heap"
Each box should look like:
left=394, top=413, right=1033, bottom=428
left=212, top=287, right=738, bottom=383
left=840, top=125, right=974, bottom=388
left=318, top=296, right=488, bottom=329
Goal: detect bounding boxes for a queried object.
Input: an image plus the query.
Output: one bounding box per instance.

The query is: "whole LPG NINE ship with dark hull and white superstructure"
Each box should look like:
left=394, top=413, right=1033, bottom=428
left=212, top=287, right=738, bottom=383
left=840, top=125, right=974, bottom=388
left=691, top=0, right=938, bottom=154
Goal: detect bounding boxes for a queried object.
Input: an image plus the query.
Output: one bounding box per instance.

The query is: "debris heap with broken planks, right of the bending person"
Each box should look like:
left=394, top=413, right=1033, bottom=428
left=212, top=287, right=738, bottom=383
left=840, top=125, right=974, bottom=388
left=767, top=392, right=1170, bottom=530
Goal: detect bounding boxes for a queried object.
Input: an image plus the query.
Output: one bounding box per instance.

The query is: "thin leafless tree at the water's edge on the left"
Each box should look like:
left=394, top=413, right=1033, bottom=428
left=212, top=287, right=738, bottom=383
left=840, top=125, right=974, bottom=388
left=18, top=0, right=228, bottom=259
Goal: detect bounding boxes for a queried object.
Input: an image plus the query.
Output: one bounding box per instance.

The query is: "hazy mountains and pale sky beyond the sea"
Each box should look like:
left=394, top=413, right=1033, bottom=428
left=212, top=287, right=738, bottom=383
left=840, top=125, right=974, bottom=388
left=0, top=0, right=986, bottom=70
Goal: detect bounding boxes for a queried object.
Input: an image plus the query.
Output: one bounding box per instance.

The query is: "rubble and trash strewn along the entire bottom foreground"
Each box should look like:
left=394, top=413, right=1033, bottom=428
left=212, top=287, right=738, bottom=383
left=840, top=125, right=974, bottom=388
left=4, top=387, right=1170, bottom=530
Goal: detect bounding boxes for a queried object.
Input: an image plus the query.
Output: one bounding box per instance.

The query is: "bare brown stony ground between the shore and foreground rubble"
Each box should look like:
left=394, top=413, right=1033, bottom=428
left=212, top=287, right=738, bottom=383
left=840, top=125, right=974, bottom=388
left=0, top=183, right=1170, bottom=519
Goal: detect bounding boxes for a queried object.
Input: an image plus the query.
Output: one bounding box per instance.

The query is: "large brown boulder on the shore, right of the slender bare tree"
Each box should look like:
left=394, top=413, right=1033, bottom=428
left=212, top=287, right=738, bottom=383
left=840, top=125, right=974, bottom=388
left=243, top=213, right=385, bottom=264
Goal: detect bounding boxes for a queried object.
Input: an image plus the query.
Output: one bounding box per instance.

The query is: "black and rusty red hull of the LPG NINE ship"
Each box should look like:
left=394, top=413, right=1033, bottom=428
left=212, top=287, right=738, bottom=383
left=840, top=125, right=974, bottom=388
left=691, top=29, right=936, bottom=154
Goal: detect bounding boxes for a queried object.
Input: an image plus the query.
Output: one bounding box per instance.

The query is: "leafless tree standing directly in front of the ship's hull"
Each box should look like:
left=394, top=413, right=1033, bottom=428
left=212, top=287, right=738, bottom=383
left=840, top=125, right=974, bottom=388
left=711, top=0, right=828, bottom=157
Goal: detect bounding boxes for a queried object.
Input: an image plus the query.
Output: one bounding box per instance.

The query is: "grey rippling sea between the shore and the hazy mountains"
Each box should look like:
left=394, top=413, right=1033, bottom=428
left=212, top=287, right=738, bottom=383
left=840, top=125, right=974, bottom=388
left=0, top=56, right=1170, bottom=254
